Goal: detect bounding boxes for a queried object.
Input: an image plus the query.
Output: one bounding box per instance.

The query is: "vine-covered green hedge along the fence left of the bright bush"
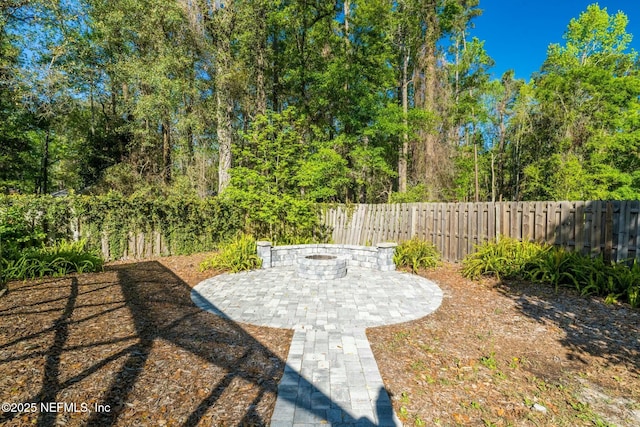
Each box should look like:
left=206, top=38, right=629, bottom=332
left=0, top=193, right=243, bottom=259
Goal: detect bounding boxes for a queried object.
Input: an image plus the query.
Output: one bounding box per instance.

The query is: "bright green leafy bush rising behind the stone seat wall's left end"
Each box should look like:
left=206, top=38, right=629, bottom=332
left=221, top=108, right=336, bottom=244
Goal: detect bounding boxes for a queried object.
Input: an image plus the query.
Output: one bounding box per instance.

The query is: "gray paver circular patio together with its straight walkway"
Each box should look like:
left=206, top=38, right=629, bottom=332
left=192, top=267, right=442, bottom=427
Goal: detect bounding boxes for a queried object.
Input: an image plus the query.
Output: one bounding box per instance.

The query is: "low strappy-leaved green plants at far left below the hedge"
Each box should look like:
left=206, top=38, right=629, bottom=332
left=0, top=241, right=103, bottom=282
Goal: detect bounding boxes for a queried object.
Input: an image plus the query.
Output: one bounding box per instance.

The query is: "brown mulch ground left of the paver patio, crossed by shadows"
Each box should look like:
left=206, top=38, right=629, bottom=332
left=0, top=255, right=293, bottom=426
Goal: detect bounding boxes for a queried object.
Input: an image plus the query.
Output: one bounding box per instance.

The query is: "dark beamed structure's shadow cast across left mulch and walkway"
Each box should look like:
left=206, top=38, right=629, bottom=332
left=0, top=261, right=392, bottom=427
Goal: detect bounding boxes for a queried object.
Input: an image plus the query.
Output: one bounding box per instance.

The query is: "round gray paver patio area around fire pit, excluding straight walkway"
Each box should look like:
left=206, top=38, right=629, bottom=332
left=192, top=267, right=442, bottom=330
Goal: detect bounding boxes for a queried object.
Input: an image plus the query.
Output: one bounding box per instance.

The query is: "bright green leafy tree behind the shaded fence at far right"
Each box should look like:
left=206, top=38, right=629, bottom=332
left=523, top=5, right=640, bottom=200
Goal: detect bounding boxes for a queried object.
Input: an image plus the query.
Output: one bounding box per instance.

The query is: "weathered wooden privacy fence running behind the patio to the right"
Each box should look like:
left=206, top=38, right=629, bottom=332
left=322, top=200, right=640, bottom=261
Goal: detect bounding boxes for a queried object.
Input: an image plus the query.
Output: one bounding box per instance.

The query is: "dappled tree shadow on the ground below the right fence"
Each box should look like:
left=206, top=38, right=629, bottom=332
left=498, top=280, right=640, bottom=374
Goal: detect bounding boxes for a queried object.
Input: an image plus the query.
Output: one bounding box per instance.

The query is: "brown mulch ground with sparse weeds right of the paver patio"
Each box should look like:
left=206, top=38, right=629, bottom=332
left=367, top=265, right=640, bottom=427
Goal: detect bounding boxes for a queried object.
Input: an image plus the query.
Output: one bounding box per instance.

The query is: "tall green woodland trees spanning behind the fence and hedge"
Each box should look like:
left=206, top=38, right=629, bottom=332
left=0, top=0, right=640, bottom=202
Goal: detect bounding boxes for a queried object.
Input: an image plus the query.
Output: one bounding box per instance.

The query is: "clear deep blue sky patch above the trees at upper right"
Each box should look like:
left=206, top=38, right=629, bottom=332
left=471, top=0, right=640, bottom=80
